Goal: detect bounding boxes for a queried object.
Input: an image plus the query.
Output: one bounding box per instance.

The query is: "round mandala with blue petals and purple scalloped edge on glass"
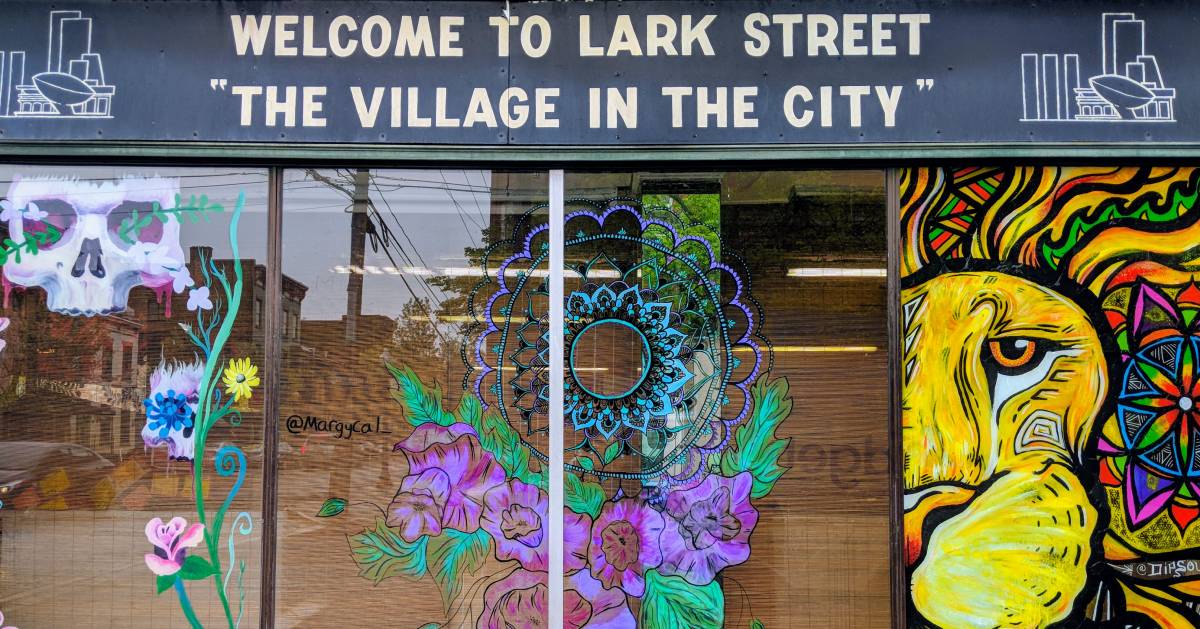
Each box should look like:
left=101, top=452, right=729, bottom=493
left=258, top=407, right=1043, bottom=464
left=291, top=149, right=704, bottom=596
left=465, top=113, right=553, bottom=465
left=463, top=199, right=770, bottom=485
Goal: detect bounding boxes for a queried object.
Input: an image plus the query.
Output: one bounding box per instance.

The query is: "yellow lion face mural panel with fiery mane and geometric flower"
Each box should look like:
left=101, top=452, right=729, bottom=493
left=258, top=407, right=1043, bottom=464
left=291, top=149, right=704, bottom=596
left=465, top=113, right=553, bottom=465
left=900, top=167, right=1200, bottom=629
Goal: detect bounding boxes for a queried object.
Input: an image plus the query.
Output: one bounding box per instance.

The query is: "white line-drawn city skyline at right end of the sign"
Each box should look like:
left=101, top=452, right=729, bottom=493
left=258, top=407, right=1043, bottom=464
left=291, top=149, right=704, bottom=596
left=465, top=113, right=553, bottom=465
left=1021, top=13, right=1175, bottom=122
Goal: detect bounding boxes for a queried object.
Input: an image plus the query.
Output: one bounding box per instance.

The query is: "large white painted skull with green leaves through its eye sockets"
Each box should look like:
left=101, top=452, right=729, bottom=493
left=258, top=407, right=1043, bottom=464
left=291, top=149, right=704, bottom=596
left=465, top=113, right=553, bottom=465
left=2, top=176, right=185, bottom=317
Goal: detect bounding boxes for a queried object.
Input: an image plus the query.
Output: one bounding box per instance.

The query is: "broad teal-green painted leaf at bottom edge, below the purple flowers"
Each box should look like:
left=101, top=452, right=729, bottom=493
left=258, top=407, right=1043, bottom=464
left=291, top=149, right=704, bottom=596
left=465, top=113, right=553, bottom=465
left=638, top=570, right=725, bottom=629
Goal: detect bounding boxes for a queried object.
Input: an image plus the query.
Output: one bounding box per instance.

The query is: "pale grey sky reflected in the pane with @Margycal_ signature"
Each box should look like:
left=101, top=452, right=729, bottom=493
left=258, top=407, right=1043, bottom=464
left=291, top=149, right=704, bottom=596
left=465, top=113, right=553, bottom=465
left=283, top=169, right=542, bottom=319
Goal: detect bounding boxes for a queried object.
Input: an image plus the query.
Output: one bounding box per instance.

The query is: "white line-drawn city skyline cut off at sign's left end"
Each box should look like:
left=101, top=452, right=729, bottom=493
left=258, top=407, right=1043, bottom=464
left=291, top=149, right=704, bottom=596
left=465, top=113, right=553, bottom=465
left=0, top=11, right=116, bottom=119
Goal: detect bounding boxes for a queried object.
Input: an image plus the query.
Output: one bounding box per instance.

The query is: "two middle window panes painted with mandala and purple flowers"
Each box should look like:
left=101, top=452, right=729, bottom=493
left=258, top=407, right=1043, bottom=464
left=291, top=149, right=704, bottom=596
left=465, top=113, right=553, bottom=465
left=277, top=169, right=889, bottom=628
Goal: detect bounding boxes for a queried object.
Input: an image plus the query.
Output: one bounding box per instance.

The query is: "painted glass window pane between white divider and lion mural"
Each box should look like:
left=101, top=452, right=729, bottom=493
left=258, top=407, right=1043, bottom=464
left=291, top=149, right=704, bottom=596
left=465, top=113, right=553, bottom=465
left=564, top=170, right=889, bottom=628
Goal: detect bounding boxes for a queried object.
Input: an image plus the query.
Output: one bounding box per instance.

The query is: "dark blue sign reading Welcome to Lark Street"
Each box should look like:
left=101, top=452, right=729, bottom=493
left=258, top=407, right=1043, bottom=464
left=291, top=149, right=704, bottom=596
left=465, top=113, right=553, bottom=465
left=0, top=1, right=1200, bottom=145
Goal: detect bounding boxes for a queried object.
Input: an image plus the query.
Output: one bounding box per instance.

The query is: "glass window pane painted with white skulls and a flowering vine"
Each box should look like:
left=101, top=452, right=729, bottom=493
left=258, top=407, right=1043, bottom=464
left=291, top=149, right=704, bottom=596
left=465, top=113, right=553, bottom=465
left=0, top=166, right=266, bottom=629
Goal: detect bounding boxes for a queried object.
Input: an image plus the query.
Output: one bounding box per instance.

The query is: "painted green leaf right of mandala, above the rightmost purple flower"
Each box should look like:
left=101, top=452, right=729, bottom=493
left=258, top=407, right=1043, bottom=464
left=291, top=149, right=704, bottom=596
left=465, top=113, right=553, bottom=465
left=721, top=378, right=792, bottom=498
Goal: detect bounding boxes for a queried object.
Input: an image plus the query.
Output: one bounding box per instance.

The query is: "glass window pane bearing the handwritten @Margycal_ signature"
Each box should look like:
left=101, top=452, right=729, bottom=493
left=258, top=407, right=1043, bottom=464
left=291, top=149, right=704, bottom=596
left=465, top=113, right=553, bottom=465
left=277, top=169, right=548, bottom=627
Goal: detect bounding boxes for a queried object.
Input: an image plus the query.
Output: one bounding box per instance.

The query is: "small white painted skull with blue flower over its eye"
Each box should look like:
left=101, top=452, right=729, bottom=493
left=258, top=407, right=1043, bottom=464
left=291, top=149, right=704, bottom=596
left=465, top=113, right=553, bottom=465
left=142, top=360, right=204, bottom=461
